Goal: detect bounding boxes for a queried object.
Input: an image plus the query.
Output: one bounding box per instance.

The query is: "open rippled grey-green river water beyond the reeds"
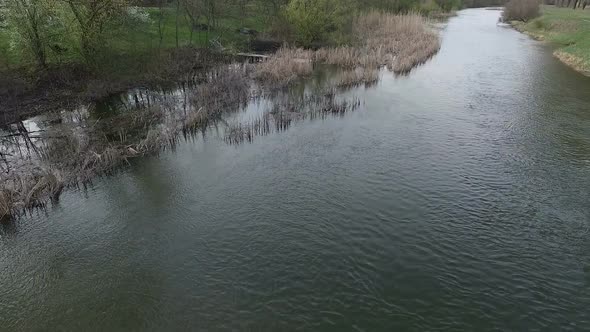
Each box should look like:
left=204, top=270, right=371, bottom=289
left=0, top=10, right=590, bottom=331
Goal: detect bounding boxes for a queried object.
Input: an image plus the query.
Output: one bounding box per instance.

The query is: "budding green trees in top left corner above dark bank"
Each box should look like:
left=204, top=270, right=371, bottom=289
left=3, top=0, right=149, bottom=68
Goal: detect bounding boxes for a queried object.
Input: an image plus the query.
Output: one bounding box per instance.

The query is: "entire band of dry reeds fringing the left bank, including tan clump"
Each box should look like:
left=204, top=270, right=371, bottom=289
left=0, top=12, right=440, bottom=222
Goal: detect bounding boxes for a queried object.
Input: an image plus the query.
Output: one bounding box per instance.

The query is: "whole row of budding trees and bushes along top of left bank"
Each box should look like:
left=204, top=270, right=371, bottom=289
left=0, top=0, right=468, bottom=69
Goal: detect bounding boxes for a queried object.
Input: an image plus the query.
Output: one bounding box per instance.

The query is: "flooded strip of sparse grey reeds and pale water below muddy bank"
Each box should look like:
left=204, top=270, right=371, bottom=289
left=0, top=65, right=370, bottom=219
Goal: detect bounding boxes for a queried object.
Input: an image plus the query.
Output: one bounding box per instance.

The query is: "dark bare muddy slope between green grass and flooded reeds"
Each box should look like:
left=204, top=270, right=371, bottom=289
left=0, top=47, right=232, bottom=126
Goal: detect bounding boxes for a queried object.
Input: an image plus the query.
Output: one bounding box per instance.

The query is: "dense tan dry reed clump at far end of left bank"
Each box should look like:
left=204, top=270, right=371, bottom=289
left=255, top=11, right=440, bottom=87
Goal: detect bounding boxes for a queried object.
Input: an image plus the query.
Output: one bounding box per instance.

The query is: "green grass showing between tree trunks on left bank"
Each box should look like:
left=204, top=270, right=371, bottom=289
left=0, top=8, right=265, bottom=70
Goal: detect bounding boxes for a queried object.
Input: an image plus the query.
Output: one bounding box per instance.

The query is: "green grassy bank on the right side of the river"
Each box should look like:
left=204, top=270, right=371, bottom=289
left=512, top=6, right=590, bottom=76
